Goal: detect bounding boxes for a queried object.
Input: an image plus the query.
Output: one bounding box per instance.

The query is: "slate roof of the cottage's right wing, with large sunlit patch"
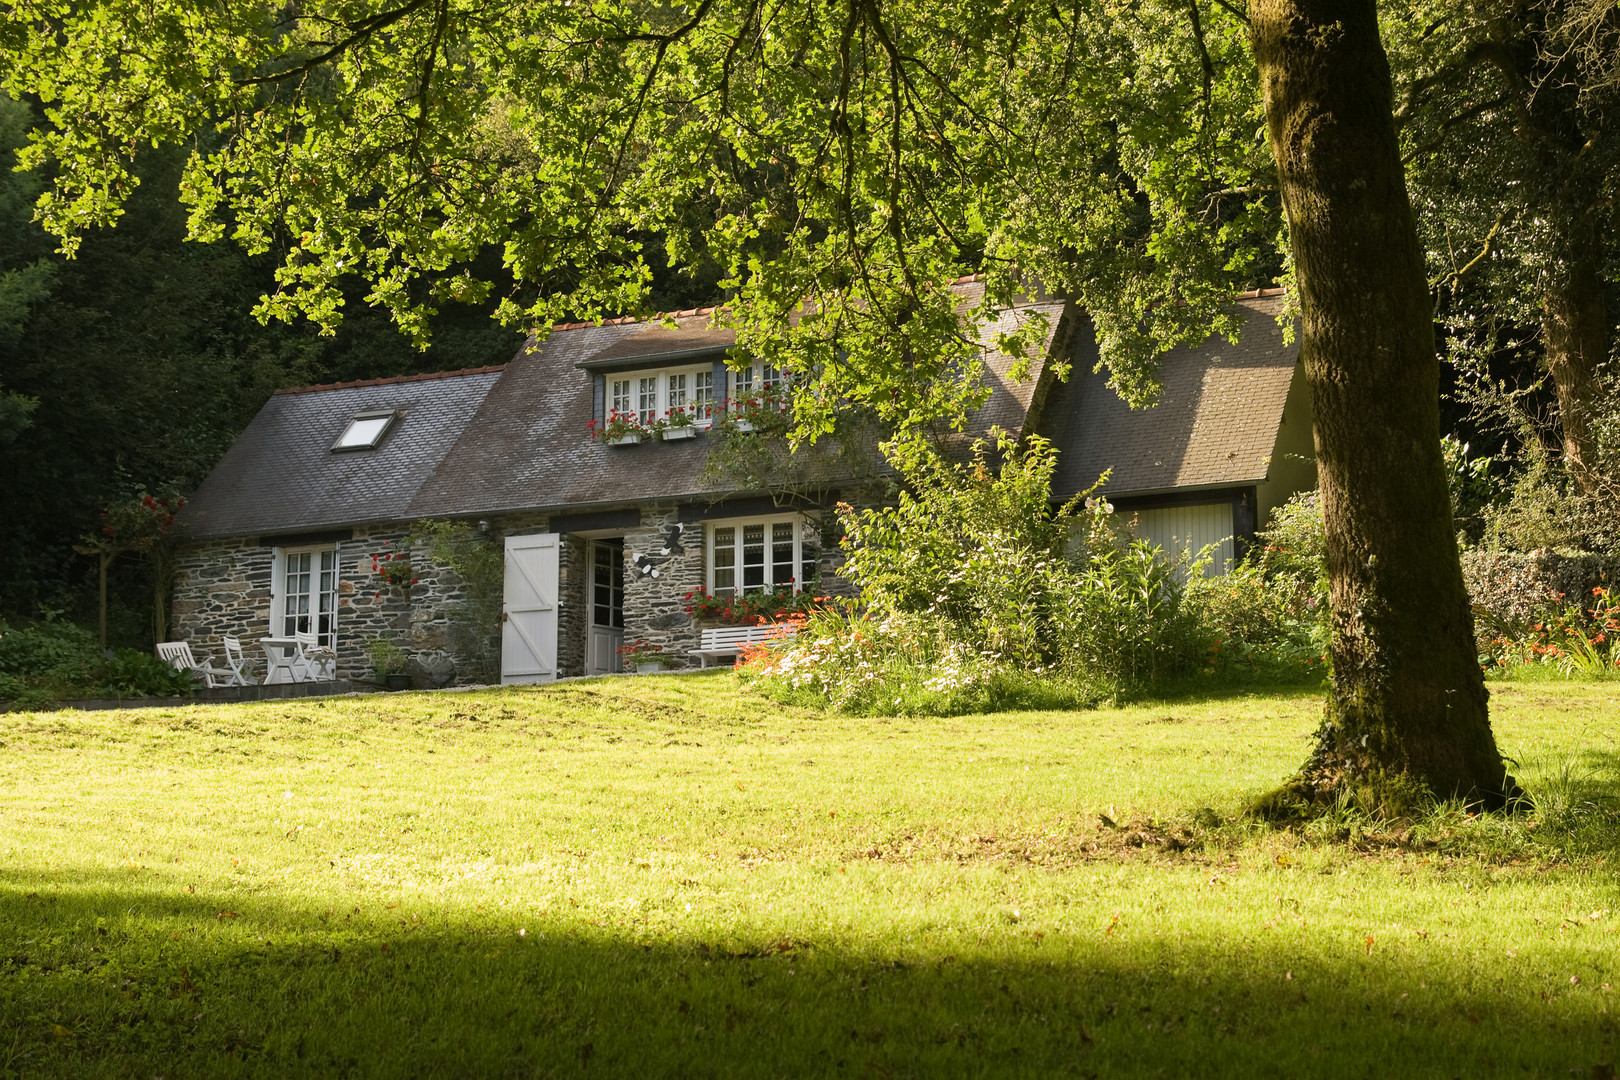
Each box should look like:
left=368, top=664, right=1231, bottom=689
left=1040, top=290, right=1299, bottom=499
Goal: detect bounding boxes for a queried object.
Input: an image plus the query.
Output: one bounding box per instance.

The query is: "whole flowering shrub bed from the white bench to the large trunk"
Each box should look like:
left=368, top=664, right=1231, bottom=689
left=740, top=436, right=1327, bottom=714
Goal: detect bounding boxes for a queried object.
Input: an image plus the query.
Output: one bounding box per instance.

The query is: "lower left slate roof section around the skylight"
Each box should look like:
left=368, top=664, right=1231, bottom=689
left=185, top=368, right=502, bottom=539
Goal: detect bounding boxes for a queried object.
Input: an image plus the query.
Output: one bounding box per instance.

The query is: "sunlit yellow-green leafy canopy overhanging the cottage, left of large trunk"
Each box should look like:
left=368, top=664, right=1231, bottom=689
left=3, top=0, right=1278, bottom=437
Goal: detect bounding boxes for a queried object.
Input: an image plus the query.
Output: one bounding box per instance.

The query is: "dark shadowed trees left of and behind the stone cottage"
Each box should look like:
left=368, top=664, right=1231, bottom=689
left=0, top=94, right=522, bottom=637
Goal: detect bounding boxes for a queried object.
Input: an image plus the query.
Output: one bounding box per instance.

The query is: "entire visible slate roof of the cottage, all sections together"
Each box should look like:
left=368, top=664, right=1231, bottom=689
left=188, top=280, right=1298, bottom=539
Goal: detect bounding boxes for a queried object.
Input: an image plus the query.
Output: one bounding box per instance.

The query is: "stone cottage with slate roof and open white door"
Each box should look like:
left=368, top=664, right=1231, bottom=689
left=173, top=280, right=1314, bottom=685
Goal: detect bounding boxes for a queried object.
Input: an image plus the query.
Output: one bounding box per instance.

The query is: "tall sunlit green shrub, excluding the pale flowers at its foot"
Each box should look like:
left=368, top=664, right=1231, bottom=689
left=842, top=431, right=1200, bottom=687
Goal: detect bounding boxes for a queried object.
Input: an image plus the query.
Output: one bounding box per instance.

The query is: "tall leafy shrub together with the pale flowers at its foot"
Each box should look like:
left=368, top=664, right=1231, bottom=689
left=744, top=432, right=1202, bottom=712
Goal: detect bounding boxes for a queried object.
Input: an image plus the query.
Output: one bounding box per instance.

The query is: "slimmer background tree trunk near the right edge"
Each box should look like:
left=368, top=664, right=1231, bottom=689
left=1541, top=226, right=1615, bottom=495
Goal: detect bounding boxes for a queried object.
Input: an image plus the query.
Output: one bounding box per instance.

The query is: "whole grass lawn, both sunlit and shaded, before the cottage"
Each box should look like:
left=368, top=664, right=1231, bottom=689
left=0, top=674, right=1620, bottom=1078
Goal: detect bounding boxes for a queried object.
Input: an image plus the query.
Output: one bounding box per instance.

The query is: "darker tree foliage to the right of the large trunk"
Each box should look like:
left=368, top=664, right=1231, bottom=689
left=1385, top=0, right=1620, bottom=512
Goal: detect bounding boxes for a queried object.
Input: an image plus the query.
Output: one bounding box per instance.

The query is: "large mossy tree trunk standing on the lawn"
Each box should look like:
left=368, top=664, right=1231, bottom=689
left=1249, top=0, right=1516, bottom=813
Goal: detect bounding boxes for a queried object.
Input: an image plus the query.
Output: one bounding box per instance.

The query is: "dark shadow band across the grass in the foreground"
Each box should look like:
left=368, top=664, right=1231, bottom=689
left=0, top=873, right=1615, bottom=1078
